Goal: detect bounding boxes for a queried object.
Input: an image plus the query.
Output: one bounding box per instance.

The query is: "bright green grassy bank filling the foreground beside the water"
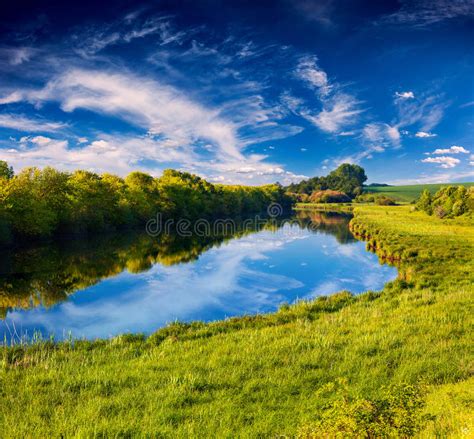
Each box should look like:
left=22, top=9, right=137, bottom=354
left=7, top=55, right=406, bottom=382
left=0, top=206, right=474, bottom=438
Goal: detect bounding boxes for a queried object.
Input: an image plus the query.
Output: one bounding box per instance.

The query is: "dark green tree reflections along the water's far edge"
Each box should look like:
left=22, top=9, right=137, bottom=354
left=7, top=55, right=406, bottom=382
left=0, top=211, right=355, bottom=318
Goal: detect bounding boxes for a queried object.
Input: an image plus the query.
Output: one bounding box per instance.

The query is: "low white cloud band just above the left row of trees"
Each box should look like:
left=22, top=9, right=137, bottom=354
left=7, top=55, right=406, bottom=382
left=0, top=134, right=308, bottom=184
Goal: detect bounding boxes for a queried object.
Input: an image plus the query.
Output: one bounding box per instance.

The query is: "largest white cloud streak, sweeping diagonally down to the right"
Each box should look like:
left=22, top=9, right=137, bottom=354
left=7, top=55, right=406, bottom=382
left=21, top=69, right=243, bottom=159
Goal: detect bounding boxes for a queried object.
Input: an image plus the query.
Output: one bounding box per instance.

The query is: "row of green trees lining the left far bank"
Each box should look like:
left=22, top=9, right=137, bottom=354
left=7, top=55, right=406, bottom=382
left=0, top=162, right=291, bottom=246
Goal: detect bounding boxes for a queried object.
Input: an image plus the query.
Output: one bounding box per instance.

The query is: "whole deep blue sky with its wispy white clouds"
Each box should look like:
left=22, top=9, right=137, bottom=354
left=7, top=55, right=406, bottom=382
left=0, top=0, right=474, bottom=184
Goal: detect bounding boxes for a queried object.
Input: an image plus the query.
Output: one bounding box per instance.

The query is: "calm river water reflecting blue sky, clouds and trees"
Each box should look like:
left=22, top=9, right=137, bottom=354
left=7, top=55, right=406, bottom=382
left=0, top=212, right=397, bottom=340
